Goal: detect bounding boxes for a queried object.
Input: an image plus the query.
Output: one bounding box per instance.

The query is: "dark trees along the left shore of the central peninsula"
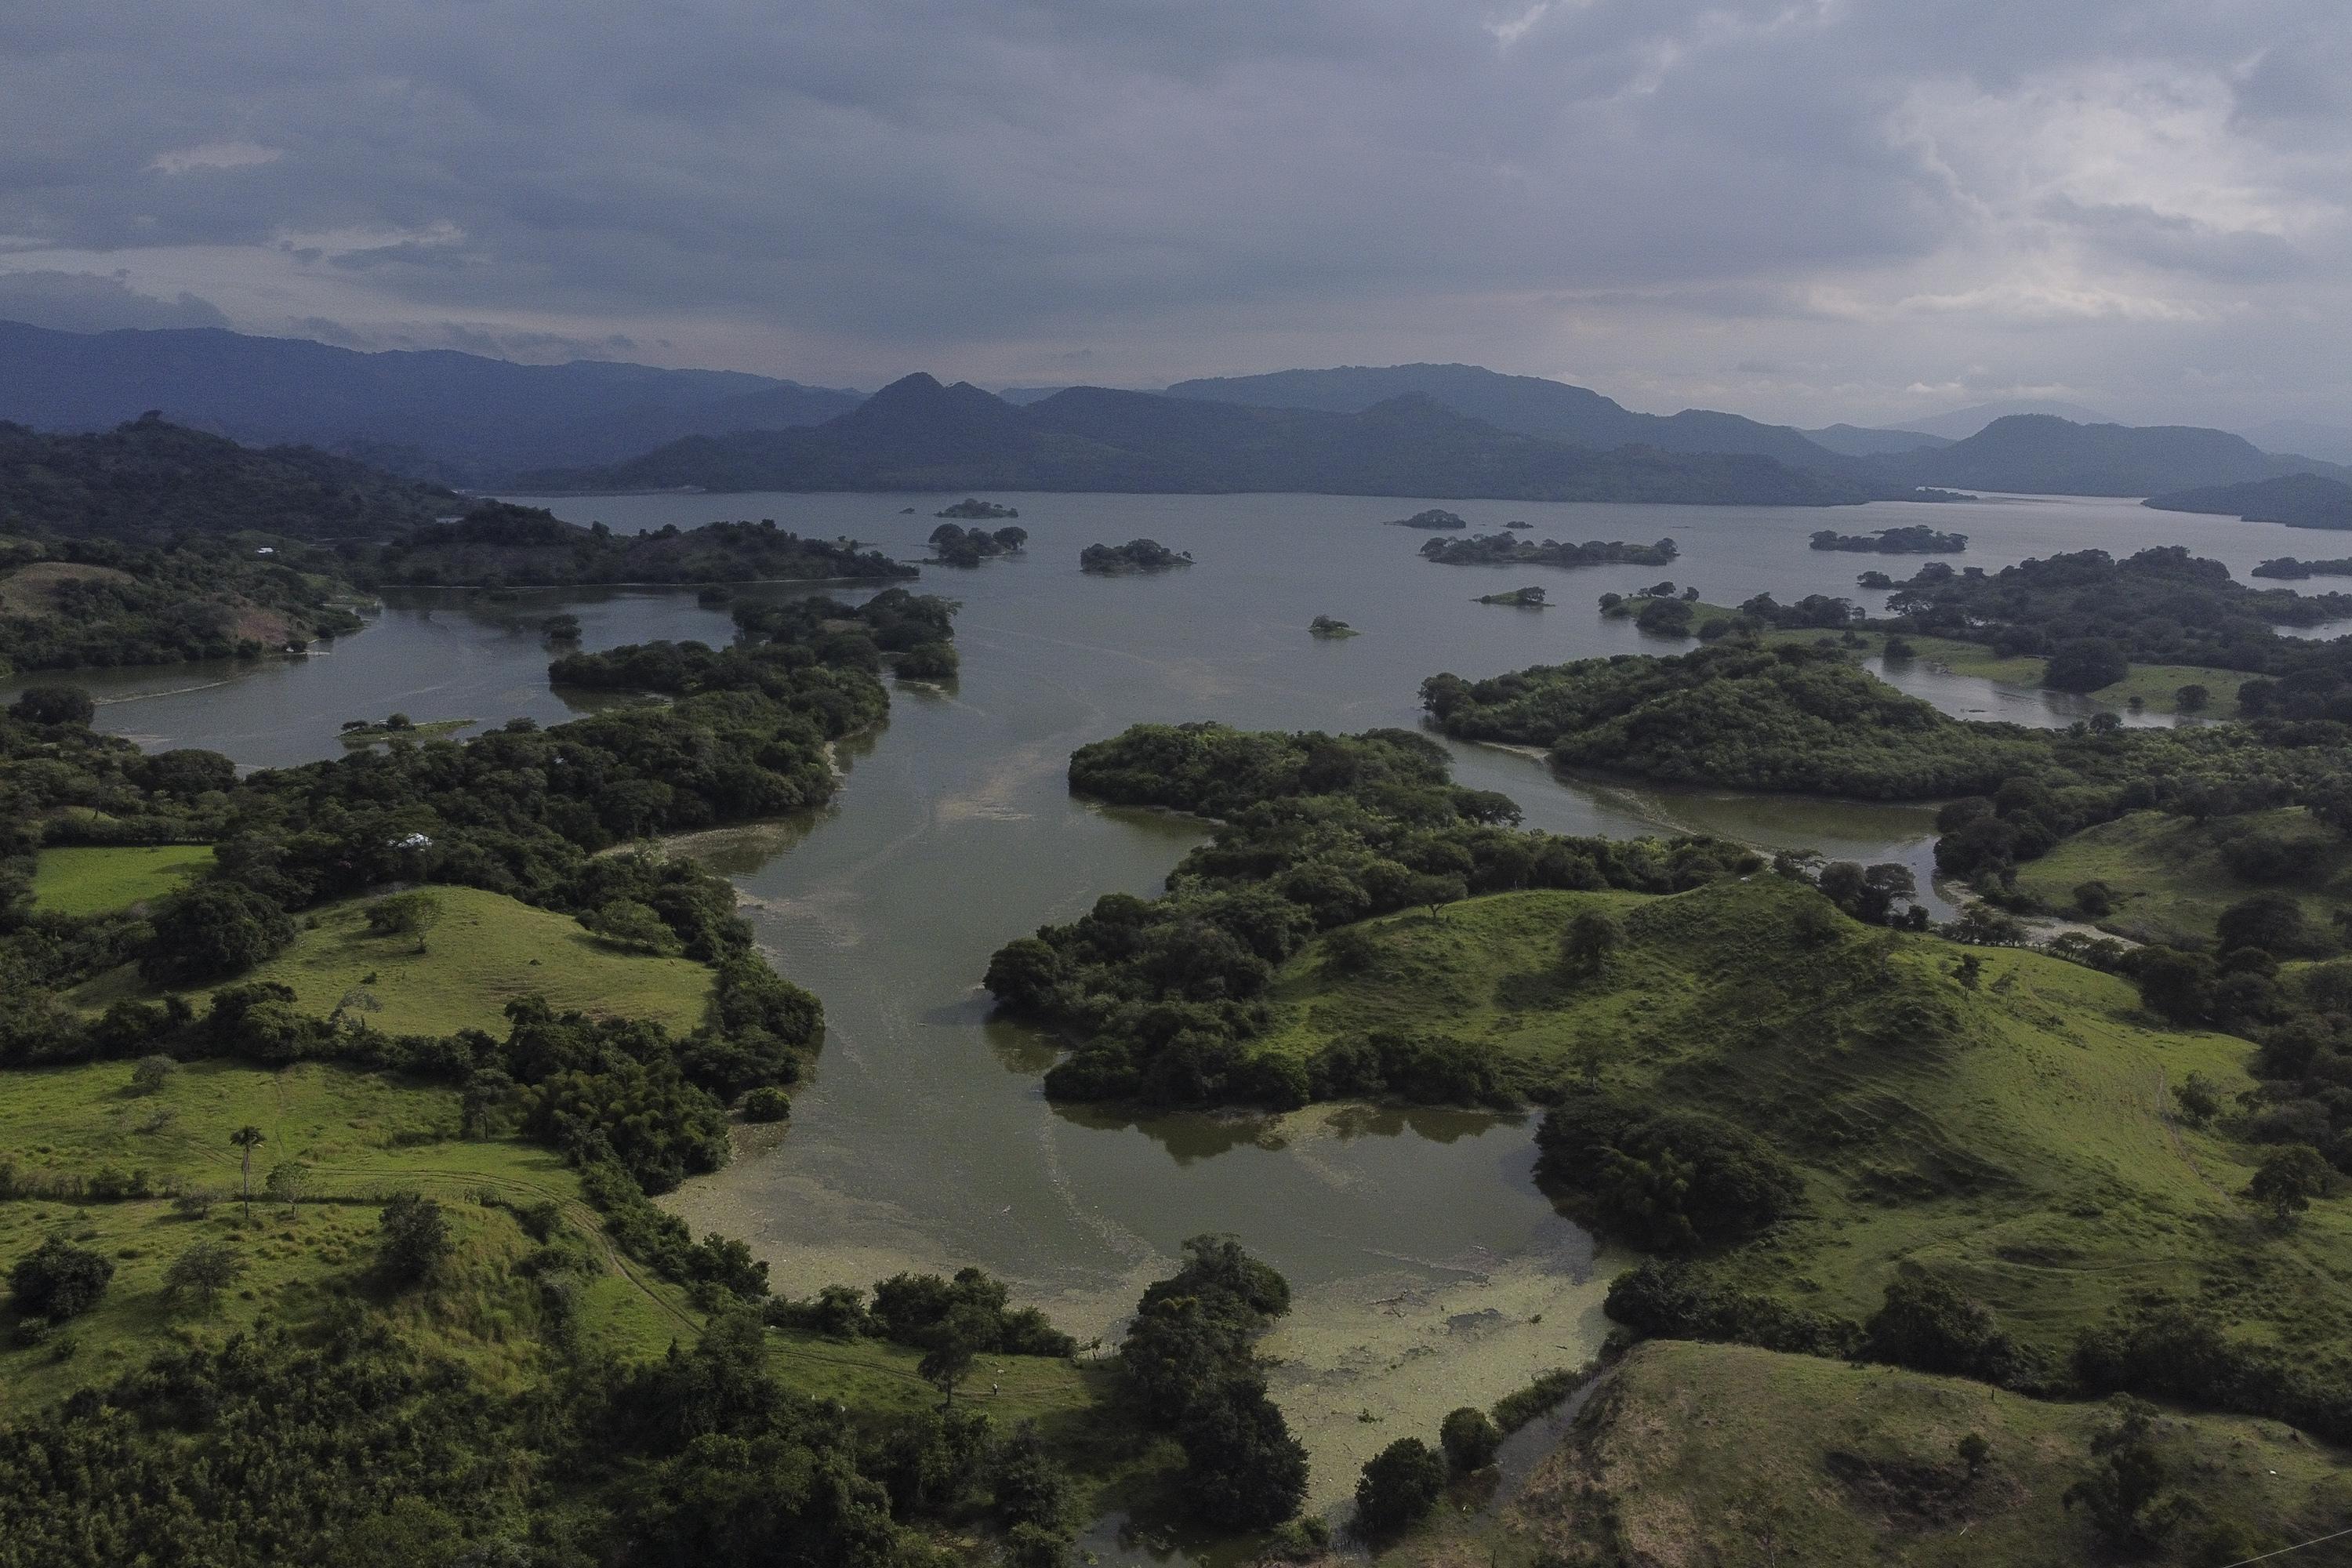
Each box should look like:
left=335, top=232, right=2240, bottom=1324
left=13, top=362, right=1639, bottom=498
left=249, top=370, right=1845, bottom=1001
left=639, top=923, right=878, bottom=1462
left=988, top=724, right=1757, bottom=1107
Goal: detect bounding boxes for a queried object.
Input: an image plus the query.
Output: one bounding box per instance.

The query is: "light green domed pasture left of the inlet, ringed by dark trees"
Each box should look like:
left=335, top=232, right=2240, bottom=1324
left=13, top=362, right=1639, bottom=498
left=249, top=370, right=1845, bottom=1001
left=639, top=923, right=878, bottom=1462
left=73, top=884, right=710, bottom=1034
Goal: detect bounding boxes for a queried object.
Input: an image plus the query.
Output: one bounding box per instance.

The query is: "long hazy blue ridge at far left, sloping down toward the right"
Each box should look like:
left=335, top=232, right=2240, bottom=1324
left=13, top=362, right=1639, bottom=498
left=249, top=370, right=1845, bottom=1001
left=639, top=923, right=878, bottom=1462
left=0, top=322, right=863, bottom=485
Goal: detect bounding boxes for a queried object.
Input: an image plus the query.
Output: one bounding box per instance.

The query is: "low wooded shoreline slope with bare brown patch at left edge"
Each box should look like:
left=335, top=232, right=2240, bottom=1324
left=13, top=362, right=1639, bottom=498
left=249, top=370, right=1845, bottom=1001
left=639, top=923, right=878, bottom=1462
left=0, top=534, right=360, bottom=670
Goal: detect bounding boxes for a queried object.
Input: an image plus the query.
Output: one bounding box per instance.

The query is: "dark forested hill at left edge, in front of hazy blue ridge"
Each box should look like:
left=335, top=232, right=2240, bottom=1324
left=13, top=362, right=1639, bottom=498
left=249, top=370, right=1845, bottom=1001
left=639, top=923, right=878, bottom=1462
left=0, top=416, right=463, bottom=543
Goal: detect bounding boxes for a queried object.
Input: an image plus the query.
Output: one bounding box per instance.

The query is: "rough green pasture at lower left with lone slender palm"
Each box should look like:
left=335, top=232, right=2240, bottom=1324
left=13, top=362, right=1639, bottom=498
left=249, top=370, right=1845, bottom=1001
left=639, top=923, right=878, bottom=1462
left=0, top=1062, right=694, bottom=1415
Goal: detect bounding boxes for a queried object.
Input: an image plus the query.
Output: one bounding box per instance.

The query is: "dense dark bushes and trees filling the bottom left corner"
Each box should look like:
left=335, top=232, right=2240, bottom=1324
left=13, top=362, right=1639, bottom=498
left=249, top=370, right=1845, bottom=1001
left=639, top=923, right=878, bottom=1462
left=0, top=1312, right=1068, bottom=1568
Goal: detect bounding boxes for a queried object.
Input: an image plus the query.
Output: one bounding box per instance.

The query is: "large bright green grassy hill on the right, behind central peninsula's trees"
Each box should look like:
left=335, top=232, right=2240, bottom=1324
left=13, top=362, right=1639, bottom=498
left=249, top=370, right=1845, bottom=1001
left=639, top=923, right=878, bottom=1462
left=1263, top=879, right=2352, bottom=1363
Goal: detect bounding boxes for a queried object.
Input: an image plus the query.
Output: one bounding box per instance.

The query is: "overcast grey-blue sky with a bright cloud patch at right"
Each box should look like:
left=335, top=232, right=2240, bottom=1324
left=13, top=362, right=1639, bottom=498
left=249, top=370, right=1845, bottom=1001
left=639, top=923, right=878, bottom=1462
left=0, top=0, right=2352, bottom=428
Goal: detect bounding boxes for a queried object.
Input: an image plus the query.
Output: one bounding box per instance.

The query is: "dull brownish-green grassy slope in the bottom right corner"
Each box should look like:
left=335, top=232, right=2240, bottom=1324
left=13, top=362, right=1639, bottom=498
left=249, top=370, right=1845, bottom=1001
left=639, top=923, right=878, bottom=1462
left=1383, top=1342, right=2352, bottom=1568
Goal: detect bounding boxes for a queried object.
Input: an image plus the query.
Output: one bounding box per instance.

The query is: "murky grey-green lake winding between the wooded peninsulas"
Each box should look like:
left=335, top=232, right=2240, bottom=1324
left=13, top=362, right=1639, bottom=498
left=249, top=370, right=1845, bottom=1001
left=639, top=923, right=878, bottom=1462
left=13, top=494, right=2307, bottom=1504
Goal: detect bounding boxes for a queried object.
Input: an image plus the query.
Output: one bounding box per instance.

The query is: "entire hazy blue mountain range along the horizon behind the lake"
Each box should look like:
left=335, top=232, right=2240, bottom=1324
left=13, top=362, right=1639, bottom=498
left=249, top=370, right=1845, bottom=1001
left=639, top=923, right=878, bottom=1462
left=0, top=322, right=2352, bottom=506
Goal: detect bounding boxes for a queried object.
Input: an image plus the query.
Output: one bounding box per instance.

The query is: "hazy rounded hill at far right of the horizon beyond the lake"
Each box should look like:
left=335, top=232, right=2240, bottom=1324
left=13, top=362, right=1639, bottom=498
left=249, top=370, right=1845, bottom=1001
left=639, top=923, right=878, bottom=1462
left=1865, top=414, right=2352, bottom=496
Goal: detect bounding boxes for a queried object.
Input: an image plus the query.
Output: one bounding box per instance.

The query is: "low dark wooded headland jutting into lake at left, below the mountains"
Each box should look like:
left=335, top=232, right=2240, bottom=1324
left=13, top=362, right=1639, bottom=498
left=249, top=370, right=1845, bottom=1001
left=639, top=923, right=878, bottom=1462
left=372, top=501, right=915, bottom=588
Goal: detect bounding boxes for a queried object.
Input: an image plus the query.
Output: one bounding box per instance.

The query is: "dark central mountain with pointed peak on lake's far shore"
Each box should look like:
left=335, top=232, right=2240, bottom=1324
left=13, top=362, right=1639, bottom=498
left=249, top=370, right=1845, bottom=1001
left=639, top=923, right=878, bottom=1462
left=520, top=374, right=1900, bottom=506
